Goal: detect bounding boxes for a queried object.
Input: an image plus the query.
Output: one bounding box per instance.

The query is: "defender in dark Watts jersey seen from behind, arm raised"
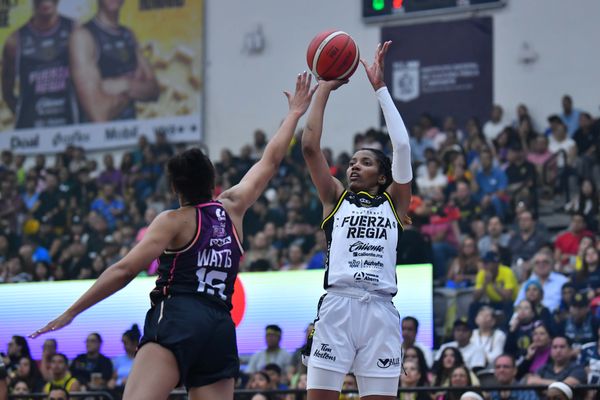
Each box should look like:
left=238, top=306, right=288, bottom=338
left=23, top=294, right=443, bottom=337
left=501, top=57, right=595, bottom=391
left=31, top=72, right=315, bottom=400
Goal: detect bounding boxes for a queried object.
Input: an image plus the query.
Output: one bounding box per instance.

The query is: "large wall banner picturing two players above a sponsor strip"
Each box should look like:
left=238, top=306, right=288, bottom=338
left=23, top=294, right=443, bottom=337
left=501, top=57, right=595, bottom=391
left=0, top=0, right=203, bottom=154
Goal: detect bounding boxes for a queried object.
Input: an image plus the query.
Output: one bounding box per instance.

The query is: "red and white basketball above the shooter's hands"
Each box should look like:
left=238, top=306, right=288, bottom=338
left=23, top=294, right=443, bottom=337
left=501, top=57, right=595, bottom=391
left=306, top=30, right=360, bottom=81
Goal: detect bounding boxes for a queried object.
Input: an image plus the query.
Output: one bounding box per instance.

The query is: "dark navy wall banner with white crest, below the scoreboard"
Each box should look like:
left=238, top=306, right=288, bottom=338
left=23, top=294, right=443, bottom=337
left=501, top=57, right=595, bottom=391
left=381, top=17, right=493, bottom=129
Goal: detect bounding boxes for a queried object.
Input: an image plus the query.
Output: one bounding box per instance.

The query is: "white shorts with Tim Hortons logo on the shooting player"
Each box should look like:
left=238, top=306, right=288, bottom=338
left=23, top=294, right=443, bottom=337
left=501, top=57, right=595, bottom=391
left=308, top=293, right=402, bottom=378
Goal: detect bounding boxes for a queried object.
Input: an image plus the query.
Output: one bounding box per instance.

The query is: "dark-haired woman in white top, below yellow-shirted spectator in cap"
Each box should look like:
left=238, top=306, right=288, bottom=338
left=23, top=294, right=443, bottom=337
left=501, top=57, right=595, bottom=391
left=471, top=306, right=506, bottom=367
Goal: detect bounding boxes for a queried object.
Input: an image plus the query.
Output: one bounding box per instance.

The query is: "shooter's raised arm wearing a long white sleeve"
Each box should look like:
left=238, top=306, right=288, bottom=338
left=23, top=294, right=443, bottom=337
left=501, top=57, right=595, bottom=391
left=360, top=41, right=413, bottom=217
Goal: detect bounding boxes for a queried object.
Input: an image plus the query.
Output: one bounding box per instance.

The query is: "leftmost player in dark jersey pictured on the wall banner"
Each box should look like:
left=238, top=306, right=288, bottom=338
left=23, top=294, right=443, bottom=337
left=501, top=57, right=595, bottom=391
left=2, top=0, right=79, bottom=129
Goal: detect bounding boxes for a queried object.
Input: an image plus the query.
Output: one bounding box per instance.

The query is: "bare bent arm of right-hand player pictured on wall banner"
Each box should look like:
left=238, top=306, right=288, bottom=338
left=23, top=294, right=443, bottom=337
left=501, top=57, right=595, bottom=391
left=69, top=27, right=131, bottom=122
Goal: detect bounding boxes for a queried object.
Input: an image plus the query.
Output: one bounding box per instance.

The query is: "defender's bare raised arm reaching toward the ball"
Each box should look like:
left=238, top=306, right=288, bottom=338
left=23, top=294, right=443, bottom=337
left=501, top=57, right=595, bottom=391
left=219, top=72, right=316, bottom=228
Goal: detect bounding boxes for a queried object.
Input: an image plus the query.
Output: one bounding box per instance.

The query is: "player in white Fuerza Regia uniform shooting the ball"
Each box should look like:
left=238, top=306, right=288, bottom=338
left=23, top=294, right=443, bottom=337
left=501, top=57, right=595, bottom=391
left=302, top=42, right=412, bottom=400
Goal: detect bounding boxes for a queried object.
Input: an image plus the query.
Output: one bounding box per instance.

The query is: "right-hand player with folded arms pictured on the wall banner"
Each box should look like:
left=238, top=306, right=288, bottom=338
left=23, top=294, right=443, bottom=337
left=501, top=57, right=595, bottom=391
left=70, top=0, right=159, bottom=121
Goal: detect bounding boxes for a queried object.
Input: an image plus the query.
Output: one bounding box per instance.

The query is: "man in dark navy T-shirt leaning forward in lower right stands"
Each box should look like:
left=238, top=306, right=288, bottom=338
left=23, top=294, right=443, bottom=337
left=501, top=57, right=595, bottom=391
left=526, top=336, right=587, bottom=386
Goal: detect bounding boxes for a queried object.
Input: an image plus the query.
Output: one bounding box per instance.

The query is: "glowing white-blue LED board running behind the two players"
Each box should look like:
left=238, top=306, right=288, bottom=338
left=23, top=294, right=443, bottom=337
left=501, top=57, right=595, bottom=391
left=0, top=264, right=433, bottom=359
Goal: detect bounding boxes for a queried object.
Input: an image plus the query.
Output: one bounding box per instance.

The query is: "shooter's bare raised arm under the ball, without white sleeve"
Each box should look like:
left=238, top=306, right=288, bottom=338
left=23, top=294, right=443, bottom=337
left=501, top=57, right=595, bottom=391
left=302, top=80, right=348, bottom=215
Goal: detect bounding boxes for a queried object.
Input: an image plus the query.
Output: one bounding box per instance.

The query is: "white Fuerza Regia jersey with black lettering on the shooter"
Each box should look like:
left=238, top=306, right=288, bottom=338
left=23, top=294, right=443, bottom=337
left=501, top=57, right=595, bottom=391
left=321, top=191, right=403, bottom=296
